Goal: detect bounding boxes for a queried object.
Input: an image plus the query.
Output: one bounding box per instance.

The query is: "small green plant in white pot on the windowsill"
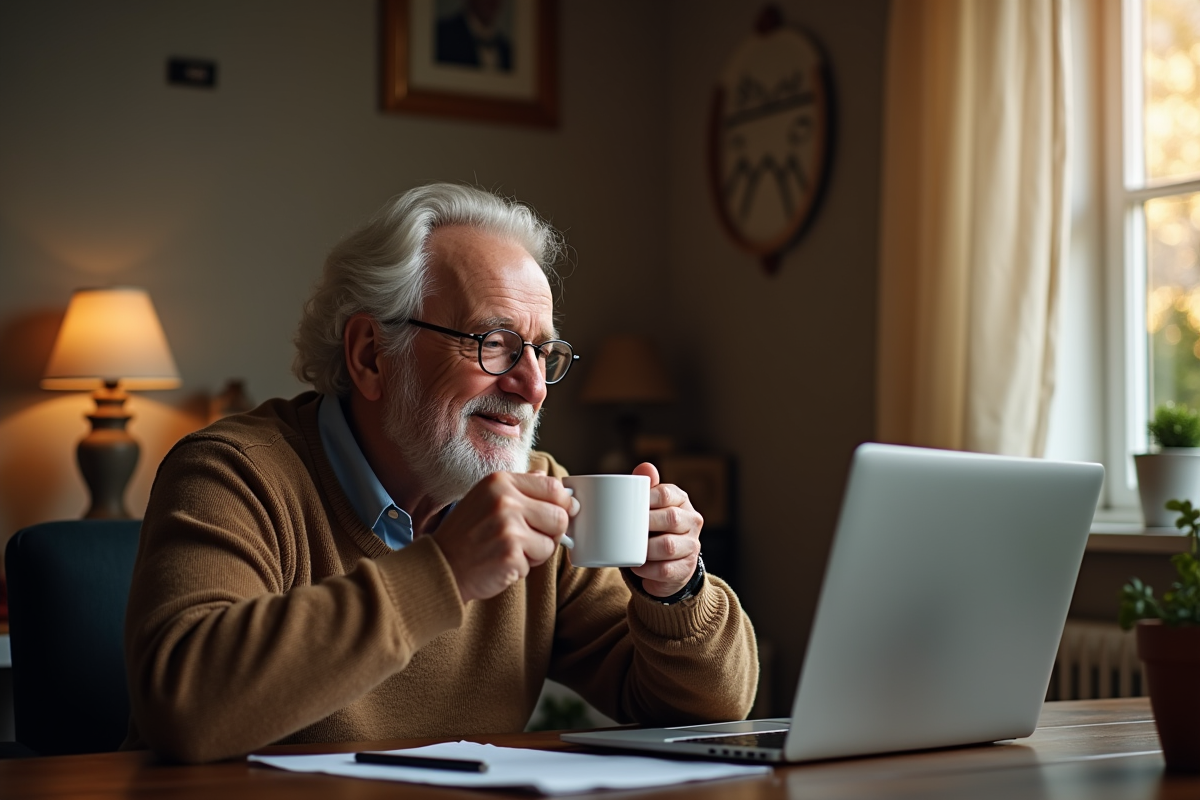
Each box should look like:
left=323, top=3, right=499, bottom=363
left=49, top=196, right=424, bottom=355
left=1133, top=403, right=1200, bottom=528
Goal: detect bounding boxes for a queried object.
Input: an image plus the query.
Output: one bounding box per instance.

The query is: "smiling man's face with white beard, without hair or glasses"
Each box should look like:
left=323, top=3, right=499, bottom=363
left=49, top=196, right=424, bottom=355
left=384, top=225, right=556, bottom=503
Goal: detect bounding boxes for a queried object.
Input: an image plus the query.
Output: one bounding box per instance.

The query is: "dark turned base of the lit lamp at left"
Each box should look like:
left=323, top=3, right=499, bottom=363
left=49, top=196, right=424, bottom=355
left=76, top=385, right=139, bottom=519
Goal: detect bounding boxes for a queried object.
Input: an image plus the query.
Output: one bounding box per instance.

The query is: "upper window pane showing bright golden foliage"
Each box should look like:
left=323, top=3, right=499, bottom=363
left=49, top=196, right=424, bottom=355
left=1144, top=0, right=1200, bottom=180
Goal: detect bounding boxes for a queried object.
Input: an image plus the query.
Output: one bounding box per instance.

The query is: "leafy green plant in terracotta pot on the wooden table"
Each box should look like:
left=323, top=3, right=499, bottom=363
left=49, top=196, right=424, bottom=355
left=1118, top=500, right=1200, bottom=772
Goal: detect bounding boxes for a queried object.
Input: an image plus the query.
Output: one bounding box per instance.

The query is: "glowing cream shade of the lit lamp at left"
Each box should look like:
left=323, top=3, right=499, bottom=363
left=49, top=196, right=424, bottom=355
left=42, top=287, right=180, bottom=391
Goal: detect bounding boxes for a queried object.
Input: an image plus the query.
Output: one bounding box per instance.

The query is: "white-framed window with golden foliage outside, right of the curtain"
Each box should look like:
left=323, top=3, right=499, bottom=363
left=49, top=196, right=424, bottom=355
left=1094, top=0, right=1200, bottom=509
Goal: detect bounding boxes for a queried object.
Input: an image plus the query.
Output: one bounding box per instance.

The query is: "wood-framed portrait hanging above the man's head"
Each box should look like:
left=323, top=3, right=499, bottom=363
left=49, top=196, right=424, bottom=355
left=383, top=0, right=558, bottom=127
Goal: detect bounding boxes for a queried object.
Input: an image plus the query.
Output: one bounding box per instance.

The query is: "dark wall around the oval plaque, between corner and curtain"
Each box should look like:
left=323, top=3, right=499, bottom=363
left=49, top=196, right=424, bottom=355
left=668, top=0, right=888, bottom=712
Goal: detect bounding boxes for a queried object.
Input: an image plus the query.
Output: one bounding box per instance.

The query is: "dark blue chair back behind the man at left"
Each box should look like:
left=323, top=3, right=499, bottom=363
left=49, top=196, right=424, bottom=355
left=5, top=519, right=142, bottom=756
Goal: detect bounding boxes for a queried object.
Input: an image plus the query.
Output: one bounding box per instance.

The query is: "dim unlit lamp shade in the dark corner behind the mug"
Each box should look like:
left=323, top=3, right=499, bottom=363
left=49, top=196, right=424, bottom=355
left=580, top=333, right=674, bottom=403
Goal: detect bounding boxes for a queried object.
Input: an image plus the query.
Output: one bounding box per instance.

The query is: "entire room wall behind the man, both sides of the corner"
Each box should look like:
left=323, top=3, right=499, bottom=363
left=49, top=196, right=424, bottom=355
left=0, top=0, right=887, bottom=705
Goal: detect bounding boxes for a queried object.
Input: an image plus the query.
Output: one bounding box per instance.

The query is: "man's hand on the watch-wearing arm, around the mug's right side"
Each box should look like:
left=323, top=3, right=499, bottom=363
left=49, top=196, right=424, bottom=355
left=632, top=463, right=704, bottom=597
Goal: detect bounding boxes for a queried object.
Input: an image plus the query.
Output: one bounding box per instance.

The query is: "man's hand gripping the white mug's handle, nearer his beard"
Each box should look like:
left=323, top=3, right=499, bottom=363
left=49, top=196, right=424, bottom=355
left=433, top=473, right=578, bottom=603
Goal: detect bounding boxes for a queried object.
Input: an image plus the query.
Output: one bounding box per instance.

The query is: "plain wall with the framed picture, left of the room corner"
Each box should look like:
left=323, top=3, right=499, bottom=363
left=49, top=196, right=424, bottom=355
left=0, top=0, right=667, bottom=543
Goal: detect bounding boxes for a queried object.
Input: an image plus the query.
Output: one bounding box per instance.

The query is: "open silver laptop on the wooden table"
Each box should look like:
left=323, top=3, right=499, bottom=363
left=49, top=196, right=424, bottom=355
left=562, top=444, right=1104, bottom=762
